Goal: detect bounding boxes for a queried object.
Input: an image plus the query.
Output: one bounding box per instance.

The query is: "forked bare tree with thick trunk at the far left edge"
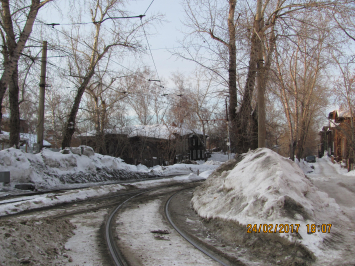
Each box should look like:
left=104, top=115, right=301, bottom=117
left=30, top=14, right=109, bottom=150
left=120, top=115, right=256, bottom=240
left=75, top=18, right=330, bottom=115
left=0, top=0, right=52, bottom=147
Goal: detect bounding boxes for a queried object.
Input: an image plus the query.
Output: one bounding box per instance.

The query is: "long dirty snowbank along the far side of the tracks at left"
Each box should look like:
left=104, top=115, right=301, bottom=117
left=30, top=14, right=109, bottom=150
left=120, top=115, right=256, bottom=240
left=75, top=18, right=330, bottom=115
left=0, top=148, right=218, bottom=190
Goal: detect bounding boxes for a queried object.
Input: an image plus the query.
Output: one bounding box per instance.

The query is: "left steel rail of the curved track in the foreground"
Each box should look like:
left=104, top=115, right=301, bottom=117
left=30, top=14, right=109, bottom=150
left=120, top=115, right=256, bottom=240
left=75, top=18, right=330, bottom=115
left=105, top=190, right=151, bottom=266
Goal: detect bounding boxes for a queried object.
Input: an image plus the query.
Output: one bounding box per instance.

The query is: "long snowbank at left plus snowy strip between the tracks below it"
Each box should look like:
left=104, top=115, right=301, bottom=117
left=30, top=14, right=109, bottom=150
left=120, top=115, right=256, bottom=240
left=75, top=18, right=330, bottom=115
left=0, top=148, right=228, bottom=216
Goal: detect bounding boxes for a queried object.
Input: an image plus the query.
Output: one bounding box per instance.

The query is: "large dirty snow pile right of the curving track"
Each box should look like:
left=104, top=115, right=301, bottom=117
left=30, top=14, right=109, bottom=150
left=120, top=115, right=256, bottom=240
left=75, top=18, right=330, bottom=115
left=192, top=148, right=339, bottom=255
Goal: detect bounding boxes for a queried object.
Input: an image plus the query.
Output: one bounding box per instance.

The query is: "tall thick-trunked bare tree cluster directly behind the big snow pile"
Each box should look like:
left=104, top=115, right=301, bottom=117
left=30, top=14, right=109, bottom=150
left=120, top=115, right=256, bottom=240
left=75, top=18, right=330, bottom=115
left=182, top=0, right=338, bottom=152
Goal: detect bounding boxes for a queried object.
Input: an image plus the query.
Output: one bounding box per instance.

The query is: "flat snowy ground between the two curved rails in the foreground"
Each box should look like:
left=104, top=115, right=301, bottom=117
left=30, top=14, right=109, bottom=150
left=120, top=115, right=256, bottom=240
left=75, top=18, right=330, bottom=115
left=116, top=196, right=220, bottom=266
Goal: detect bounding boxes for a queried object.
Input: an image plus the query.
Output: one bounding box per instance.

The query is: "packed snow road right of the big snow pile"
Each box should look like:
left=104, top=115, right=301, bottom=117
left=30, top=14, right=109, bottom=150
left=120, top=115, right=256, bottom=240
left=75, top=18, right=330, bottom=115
left=307, top=157, right=355, bottom=265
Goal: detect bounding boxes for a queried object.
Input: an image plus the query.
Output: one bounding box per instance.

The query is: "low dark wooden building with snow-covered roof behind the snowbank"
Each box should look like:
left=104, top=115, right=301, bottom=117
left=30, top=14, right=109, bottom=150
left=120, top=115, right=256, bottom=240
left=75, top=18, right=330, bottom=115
left=79, top=124, right=205, bottom=166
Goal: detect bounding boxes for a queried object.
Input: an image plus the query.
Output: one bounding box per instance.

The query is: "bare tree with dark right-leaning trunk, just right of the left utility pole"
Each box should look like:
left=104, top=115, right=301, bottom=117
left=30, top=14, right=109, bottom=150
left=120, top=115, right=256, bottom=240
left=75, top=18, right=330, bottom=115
left=62, top=0, right=156, bottom=148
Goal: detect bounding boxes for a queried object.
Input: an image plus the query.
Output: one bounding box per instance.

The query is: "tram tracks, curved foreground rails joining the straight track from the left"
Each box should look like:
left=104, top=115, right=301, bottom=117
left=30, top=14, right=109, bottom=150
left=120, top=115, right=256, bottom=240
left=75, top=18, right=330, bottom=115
left=0, top=180, right=236, bottom=266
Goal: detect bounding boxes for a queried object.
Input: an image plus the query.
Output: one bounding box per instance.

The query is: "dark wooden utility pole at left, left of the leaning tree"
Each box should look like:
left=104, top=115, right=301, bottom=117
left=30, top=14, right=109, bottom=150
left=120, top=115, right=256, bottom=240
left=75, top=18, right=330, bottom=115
left=37, top=41, right=47, bottom=151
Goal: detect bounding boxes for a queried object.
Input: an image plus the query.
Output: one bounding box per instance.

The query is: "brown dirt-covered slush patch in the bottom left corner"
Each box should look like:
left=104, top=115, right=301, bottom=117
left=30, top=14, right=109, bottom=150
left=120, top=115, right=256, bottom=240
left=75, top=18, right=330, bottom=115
left=0, top=219, right=75, bottom=266
